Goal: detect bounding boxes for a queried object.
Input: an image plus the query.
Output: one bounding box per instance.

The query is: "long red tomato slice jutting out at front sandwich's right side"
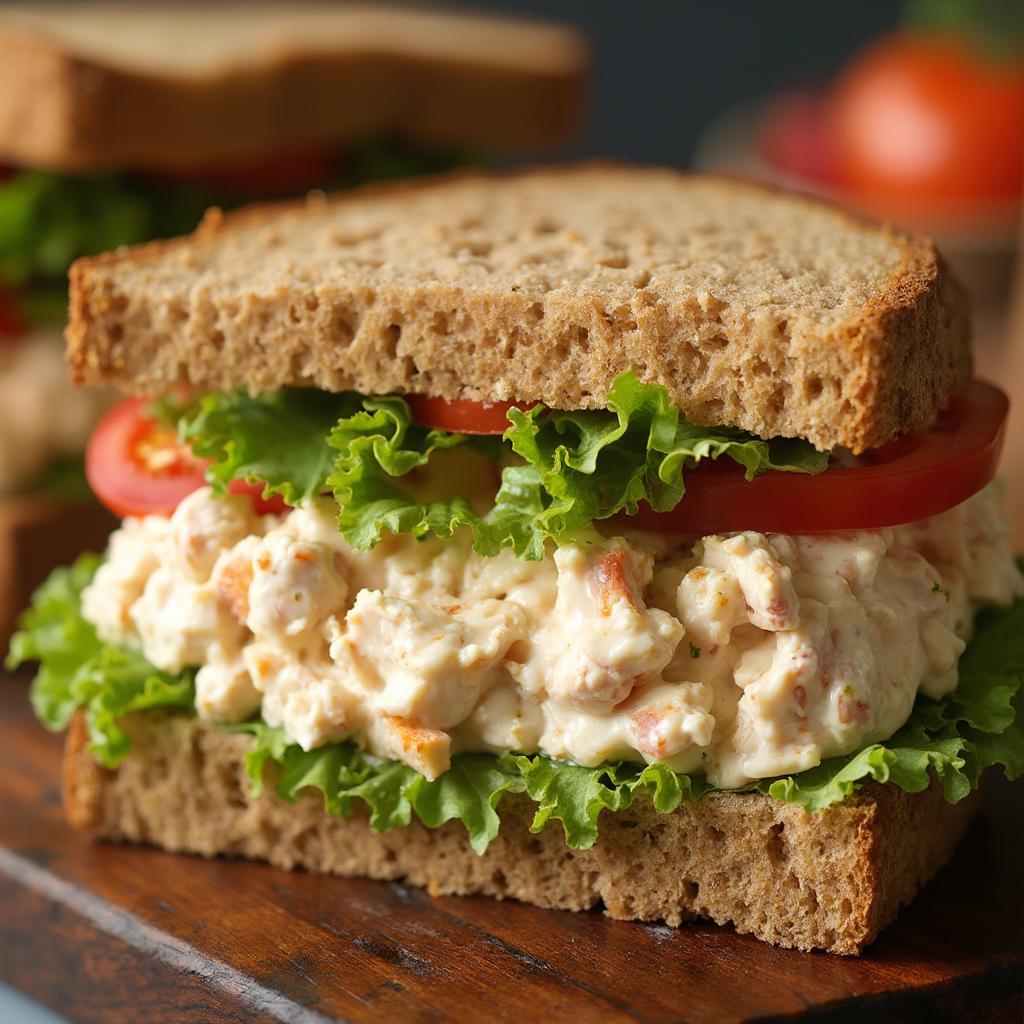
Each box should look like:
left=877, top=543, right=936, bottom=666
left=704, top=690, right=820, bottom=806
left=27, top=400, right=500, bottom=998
left=618, top=381, right=1010, bottom=536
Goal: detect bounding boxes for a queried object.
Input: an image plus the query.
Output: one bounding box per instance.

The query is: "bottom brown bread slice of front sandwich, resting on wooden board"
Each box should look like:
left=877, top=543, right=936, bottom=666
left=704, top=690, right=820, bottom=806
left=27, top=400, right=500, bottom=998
left=63, top=713, right=975, bottom=953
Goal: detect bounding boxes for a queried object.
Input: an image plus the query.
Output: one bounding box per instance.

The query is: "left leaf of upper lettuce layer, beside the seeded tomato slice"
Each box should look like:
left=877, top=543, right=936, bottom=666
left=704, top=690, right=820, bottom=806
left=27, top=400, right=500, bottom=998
left=169, top=389, right=545, bottom=558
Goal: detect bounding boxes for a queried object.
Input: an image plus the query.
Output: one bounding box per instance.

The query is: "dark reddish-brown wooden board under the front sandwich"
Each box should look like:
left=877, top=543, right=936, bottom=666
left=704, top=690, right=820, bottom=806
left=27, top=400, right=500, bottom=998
left=0, top=678, right=1024, bottom=1024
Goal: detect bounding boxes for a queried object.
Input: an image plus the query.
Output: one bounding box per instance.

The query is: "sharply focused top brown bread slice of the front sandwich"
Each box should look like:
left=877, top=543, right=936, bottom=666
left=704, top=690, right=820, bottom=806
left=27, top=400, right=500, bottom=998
left=68, top=165, right=970, bottom=452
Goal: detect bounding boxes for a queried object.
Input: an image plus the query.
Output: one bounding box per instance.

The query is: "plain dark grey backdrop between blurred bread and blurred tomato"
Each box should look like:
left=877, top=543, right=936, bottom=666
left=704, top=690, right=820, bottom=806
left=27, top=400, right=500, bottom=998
left=462, top=0, right=903, bottom=166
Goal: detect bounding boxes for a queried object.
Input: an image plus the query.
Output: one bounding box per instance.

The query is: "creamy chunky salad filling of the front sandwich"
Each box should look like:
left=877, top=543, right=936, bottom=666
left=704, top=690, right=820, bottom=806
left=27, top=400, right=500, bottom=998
left=84, top=486, right=1024, bottom=787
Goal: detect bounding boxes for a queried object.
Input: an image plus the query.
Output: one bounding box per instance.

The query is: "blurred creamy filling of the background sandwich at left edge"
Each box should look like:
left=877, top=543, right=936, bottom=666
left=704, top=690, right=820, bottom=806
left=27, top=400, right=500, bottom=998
left=0, top=331, right=110, bottom=494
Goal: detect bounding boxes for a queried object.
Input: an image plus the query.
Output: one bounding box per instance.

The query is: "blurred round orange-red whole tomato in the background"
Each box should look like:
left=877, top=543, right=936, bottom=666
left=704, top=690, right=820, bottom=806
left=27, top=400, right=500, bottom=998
left=829, top=33, right=1024, bottom=209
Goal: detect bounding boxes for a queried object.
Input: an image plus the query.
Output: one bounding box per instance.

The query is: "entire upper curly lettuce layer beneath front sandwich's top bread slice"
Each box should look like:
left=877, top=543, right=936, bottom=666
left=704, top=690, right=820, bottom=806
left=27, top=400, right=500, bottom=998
left=162, top=373, right=828, bottom=559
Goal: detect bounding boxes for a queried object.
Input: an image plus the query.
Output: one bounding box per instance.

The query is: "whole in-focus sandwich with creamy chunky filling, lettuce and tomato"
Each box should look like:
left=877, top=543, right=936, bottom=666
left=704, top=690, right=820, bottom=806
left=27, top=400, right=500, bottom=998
left=9, top=164, right=1024, bottom=954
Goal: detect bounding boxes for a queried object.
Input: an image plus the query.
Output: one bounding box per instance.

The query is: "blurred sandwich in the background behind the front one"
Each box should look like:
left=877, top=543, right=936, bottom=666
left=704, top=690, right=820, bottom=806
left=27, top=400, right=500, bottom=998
left=0, top=3, right=587, bottom=641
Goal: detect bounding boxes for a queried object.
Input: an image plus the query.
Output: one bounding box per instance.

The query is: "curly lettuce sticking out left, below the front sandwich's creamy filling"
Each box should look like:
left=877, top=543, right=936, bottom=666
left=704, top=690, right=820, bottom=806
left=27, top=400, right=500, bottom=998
left=6, top=554, right=196, bottom=768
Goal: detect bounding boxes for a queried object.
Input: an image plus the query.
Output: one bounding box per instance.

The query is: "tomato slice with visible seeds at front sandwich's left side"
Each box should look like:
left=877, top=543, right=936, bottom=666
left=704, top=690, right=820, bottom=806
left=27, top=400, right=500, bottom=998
left=85, top=398, right=286, bottom=517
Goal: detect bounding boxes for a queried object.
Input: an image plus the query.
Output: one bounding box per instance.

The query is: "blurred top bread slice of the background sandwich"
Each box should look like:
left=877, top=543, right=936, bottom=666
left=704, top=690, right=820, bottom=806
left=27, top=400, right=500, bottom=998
left=0, top=0, right=588, bottom=170
